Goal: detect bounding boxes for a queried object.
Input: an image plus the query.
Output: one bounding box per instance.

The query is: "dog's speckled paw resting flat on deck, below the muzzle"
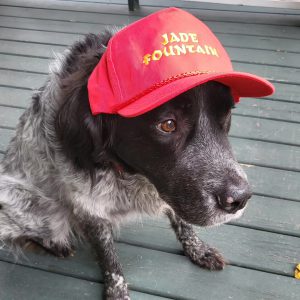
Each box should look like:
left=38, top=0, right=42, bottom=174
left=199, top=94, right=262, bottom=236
left=183, top=237, right=226, bottom=270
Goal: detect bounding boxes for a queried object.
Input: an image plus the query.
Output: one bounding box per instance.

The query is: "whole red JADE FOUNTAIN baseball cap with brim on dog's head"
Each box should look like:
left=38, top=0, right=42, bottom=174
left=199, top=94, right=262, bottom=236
left=88, top=7, right=274, bottom=117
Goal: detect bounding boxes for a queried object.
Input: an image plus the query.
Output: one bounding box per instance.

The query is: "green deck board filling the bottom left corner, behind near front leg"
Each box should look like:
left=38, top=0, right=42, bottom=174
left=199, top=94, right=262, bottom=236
left=0, top=261, right=167, bottom=300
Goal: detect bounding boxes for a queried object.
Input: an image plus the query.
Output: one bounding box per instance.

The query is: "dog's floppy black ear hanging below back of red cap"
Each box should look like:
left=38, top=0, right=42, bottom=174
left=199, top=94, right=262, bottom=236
left=55, top=87, right=114, bottom=172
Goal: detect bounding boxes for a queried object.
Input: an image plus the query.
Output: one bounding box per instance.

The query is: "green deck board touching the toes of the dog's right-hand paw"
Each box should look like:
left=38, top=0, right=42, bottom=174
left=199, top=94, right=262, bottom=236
left=1, top=244, right=300, bottom=300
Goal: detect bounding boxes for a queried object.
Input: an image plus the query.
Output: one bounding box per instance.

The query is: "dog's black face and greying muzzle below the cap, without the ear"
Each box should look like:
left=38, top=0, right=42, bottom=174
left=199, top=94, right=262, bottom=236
left=112, top=82, right=251, bottom=226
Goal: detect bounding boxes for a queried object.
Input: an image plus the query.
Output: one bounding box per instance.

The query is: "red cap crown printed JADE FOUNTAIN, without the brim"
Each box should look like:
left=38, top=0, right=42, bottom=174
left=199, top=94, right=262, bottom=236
left=89, top=8, right=232, bottom=113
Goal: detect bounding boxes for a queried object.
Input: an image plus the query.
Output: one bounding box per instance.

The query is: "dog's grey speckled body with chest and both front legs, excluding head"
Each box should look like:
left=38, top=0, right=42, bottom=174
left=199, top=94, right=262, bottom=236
left=0, top=31, right=246, bottom=299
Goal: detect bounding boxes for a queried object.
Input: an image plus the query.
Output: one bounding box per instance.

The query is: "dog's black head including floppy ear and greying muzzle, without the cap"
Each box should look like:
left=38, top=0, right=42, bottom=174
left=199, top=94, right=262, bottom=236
left=56, top=33, right=251, bottom=226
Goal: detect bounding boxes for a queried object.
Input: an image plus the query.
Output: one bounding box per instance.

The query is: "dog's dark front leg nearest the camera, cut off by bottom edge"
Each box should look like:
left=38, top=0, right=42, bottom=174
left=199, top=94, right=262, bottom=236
left=81, top=216, right=130, bottom=300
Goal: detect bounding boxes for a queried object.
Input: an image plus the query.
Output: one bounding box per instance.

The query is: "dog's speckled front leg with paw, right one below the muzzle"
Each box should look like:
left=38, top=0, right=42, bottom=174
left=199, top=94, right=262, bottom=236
left=166, top=210, right=225, bottom=270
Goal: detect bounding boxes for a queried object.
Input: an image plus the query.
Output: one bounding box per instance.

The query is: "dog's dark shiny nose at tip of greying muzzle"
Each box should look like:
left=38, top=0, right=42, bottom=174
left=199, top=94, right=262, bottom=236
left=217, top=180, right=252, bottom=214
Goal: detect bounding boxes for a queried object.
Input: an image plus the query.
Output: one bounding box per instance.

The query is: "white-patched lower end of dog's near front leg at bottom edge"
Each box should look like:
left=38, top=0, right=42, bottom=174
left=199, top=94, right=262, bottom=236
left=104, top=272, right=130, bottom=300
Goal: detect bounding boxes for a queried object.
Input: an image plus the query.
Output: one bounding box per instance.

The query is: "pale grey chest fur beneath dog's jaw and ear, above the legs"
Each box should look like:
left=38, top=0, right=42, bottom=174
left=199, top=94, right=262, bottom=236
left=70, top=170, right=166, bottom=223
